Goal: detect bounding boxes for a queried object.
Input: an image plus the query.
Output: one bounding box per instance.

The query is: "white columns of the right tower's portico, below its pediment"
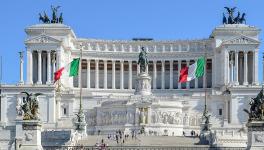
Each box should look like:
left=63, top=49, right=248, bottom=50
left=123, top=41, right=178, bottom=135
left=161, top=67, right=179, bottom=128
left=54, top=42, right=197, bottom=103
left=227, top=51, right=258, bottom=85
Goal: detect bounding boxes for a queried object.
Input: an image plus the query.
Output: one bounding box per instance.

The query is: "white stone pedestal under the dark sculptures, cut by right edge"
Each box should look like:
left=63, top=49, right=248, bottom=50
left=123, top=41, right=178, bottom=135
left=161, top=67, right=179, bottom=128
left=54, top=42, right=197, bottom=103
left=247, top=121, right=264, bottom=150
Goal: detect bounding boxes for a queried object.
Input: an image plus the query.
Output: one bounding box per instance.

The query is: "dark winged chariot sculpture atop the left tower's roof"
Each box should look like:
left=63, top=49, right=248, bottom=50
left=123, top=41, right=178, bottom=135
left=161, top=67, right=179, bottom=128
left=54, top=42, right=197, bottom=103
left=39, top=5, right=63, bottom=24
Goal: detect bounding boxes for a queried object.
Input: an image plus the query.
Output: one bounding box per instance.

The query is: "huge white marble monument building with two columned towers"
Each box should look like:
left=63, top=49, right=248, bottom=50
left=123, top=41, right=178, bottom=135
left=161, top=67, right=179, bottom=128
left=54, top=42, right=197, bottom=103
left=0, top=24, right=261, bottom=148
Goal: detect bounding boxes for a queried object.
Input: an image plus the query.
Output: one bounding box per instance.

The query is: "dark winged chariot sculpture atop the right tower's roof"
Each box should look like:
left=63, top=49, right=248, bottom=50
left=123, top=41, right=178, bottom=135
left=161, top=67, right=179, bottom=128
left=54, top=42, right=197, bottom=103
left=223, top=7, right=246, bottom=24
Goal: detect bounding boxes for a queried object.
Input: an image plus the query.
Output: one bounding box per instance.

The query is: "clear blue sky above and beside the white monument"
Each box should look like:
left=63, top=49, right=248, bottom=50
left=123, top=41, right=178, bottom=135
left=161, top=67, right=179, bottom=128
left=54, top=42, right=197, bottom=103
left=0, top=0, right=264, bottom=83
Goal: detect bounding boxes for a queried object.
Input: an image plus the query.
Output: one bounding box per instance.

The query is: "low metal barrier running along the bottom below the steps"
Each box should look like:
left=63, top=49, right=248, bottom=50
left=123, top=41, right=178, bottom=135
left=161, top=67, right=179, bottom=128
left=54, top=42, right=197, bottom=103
left=43, top=145, right=246, bottom=150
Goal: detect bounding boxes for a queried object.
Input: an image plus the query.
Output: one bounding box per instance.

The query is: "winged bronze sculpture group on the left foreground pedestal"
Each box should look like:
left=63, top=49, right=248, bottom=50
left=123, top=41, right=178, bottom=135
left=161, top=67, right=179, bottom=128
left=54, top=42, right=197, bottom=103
left=16, top=92, right=42, bottom=120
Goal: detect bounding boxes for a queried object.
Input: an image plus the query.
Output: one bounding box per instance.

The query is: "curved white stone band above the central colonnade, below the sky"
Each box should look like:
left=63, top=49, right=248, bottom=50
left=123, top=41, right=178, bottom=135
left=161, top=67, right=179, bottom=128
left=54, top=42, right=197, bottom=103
left=76, top=40, right=213, bottom=53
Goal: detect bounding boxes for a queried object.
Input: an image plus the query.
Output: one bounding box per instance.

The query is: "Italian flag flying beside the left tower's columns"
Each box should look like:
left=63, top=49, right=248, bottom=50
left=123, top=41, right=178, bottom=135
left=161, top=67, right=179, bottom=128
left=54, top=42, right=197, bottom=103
left=54, top=58, right=80, bottom=83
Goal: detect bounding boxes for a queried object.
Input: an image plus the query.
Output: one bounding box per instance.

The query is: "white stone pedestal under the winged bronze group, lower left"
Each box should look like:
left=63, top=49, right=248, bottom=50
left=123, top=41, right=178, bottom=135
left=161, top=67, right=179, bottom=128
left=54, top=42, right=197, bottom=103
left=16, top=120, right=43, bottom=150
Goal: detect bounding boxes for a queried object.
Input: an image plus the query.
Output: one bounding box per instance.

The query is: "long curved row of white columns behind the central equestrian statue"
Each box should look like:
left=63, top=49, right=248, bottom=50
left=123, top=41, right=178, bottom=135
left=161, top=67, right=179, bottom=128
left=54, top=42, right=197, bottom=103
left=74, top=59, right=211, bottom=89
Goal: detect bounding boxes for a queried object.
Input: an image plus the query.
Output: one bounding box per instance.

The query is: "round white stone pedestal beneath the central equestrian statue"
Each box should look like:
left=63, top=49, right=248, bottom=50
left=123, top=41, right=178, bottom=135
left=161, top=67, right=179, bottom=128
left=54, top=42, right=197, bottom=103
left=135, top=72, right=152, bottom=95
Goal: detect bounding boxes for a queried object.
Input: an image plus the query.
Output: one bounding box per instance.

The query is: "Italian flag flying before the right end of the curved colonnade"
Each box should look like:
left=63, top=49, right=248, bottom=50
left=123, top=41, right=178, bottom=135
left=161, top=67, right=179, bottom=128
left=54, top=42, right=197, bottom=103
left=179, top=57, right=205, bottom=83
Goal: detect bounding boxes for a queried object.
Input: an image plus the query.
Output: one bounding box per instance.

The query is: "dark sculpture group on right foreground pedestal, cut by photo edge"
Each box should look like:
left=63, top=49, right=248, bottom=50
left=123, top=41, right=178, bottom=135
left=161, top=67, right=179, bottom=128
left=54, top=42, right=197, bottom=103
left=244, top=87, right=264, bottom=122
